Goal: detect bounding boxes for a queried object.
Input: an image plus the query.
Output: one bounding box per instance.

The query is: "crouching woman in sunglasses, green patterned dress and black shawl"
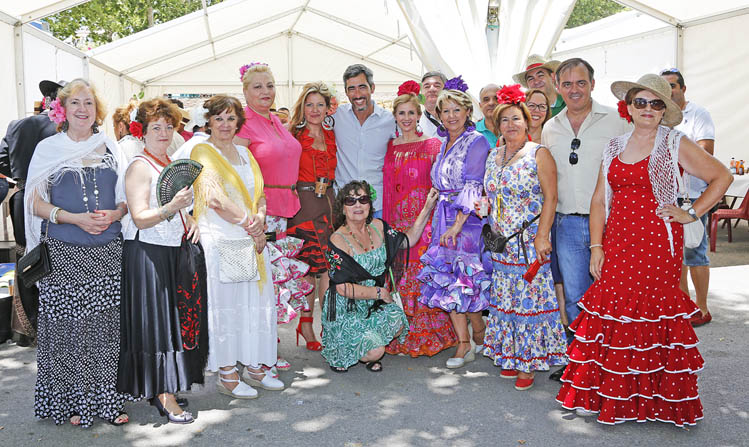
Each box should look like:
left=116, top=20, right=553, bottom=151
left=322, top=181, right=438, bottom=372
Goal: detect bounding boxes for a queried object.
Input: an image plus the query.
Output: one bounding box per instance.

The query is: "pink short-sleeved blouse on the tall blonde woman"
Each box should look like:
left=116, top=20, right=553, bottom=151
left=237, top=107, right=302, bottom=218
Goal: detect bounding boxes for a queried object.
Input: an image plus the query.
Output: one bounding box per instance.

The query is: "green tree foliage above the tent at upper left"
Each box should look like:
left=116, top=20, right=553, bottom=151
left=47, top=0, right=222, bottom=46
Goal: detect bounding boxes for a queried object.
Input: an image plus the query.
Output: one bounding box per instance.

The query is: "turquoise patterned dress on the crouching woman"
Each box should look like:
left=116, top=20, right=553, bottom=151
left=322, top=225, right=408, bottom=368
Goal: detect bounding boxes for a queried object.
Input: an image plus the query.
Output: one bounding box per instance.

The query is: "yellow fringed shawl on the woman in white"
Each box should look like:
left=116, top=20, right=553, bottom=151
left=190, top=143, right=266, bottom=292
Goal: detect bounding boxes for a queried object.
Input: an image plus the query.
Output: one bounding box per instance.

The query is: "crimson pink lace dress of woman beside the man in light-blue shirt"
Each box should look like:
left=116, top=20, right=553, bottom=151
left=382, top=138, right=458, bottom=357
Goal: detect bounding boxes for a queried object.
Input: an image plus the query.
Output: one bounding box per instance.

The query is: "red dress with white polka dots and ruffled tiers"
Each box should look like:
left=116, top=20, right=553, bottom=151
left=557, top=156, right=704, bottom=427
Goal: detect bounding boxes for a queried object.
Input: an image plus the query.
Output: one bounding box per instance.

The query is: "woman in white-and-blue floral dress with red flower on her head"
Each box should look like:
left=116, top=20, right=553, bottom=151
left=484, top=87, right=567, bottom=390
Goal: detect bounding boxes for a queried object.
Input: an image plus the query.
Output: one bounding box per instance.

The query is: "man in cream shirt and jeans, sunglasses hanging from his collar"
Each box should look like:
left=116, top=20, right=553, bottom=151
left=541, top=58, right=631, bottom=380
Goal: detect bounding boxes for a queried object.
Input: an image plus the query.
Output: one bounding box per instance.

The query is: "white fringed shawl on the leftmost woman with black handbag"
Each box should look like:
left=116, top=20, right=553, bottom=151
left=24, top=132, right=127, bottom=253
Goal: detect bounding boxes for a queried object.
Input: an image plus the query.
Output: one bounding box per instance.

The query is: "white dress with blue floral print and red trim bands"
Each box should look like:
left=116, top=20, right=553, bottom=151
left=484, top=143, right=567, bottom=373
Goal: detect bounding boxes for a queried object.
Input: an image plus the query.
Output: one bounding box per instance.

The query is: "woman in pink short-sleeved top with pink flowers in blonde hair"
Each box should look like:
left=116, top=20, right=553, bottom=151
left=234, top=62, right=313, bottom=369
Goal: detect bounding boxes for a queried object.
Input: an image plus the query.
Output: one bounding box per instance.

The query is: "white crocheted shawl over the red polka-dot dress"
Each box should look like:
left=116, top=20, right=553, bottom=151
left=601, top=126, right=684, bottom=256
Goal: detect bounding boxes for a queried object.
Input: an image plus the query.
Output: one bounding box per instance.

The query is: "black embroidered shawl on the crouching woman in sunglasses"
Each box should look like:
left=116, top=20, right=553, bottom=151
left=325, top=220, right=409, bottom=321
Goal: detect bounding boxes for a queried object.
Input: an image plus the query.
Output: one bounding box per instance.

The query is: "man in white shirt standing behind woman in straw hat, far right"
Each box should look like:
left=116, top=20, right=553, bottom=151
left=661, top=68, right=715, bottom=326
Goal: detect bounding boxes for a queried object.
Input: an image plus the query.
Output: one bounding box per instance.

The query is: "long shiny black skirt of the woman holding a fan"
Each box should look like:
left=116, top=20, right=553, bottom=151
left=117, top=238, right=208, bottom=398
